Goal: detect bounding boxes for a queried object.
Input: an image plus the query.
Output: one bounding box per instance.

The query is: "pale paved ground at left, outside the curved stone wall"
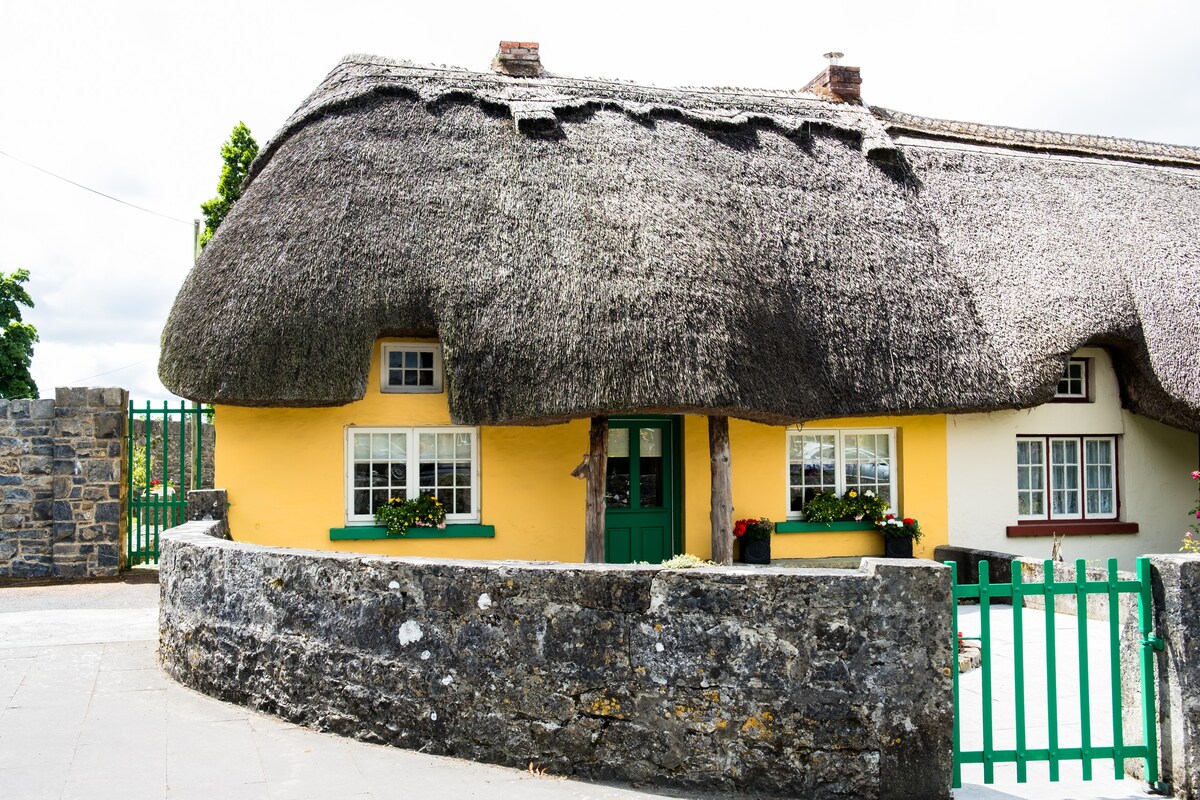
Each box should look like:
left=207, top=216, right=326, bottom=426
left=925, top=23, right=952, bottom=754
left=0, top=583, right=681, bottom=800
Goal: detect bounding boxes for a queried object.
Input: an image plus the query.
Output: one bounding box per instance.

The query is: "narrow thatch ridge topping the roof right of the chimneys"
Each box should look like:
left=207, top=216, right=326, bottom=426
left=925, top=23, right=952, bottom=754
left=871, top=106, right=1200, bottom=168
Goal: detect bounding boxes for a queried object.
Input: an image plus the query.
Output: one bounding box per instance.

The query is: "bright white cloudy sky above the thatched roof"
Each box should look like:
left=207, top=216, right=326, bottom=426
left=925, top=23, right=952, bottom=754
left=0, top=0, right=1200, bottom=401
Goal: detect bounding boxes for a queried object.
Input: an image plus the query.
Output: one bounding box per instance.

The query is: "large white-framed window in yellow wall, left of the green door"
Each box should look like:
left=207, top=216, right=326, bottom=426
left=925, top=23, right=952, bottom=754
left=346, top=427, right=479, bottom=525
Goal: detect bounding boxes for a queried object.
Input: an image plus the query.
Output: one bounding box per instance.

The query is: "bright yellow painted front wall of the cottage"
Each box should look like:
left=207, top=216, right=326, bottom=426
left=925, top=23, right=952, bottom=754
left=215, top=339, right=947, bottom=561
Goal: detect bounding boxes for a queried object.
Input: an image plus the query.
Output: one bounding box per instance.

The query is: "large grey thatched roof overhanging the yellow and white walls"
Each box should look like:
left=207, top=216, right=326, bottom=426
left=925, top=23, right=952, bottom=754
left=160, top=56, right=1200, bottom=428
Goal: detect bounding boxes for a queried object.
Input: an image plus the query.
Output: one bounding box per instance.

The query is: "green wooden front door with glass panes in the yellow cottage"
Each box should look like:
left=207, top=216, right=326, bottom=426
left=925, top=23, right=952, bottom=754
left=604, top=417, right=682, bottom=564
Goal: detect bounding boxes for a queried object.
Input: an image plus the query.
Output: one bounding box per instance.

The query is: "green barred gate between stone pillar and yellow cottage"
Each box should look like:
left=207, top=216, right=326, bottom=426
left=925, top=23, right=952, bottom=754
left=125, top=401, right=212, bottom=566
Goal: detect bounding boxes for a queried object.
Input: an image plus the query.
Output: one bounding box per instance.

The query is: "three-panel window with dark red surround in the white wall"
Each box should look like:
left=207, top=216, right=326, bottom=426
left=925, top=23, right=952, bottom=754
left=1016, top=435, right=1118, bottom=519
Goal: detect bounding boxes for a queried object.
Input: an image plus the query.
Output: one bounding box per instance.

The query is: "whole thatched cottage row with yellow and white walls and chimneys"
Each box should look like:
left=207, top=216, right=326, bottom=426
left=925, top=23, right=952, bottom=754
left=160, top=42, right=1200, bottom=561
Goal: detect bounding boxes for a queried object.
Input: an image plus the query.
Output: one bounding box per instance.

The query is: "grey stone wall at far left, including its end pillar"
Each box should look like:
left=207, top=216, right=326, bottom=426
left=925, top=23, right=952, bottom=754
left=0, top=389, right=128, bottom=578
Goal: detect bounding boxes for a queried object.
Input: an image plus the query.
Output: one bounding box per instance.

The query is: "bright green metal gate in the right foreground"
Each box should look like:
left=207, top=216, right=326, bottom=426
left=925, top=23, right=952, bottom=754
left=946, top=558, right=1165, bottom=790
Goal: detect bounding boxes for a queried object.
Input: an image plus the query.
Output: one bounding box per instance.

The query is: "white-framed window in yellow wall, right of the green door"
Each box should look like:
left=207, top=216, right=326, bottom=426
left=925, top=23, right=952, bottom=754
left=787, top=428, right=896, bottom=519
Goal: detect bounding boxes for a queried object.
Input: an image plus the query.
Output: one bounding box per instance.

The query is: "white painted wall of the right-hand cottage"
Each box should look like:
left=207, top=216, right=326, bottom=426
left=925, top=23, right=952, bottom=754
left=946, top=348, right=1200, bottom=569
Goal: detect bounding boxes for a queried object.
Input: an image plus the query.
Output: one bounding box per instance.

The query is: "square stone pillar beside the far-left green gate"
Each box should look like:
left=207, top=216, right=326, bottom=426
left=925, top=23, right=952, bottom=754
left=52, top=389, right=130, bottom=577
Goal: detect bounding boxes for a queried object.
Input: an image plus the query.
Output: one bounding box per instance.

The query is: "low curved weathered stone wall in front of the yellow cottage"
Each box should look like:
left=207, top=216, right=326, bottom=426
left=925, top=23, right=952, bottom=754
left=160, top=532, right=953, bottom=800
